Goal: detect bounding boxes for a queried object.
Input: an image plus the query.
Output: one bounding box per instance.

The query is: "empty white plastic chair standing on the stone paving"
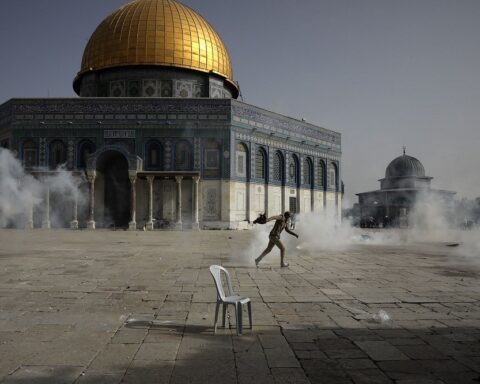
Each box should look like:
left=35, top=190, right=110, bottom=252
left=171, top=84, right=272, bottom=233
left=210, top=265, right=252, bottom=335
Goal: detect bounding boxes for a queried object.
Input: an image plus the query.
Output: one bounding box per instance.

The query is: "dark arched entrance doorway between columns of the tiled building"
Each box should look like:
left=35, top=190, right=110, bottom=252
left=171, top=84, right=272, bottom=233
left=96, top=150, right=131, bottom=227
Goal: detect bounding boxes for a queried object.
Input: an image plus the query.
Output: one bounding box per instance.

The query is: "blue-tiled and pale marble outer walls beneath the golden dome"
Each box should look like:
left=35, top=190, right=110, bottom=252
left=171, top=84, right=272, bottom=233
left=0, top=98, right=341, bottom=228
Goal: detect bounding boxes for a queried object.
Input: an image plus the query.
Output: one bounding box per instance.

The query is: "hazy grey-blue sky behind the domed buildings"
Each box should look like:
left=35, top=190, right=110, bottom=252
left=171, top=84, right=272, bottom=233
left=0, top=0, right=480, bottom=204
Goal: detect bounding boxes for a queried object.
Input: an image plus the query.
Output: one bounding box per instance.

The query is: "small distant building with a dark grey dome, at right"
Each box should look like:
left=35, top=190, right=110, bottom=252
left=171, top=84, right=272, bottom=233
left=357, top=149, right=455, bottom=227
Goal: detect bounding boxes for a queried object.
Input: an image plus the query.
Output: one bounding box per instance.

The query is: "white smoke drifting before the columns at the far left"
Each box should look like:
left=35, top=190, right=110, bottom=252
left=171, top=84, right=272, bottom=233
left=0, top=148, right=86, bottom=228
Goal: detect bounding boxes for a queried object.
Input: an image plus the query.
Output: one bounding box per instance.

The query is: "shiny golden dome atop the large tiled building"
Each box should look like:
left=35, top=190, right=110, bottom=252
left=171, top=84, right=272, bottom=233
left=77, top=0, right=238, bottom=88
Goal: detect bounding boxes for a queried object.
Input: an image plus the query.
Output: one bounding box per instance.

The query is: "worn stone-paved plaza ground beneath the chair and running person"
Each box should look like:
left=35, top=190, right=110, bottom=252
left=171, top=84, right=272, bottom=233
left=0, top=230, right=480, bottom=384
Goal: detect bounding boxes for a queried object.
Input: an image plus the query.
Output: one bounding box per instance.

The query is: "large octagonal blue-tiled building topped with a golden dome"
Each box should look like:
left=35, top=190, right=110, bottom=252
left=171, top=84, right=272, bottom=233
left=0, top=0, right=342, bottom=229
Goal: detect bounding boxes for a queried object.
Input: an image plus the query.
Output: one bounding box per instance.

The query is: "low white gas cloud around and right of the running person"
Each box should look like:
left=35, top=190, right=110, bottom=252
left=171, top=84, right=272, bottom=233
left=232, top=195, right=480, bottom=264
